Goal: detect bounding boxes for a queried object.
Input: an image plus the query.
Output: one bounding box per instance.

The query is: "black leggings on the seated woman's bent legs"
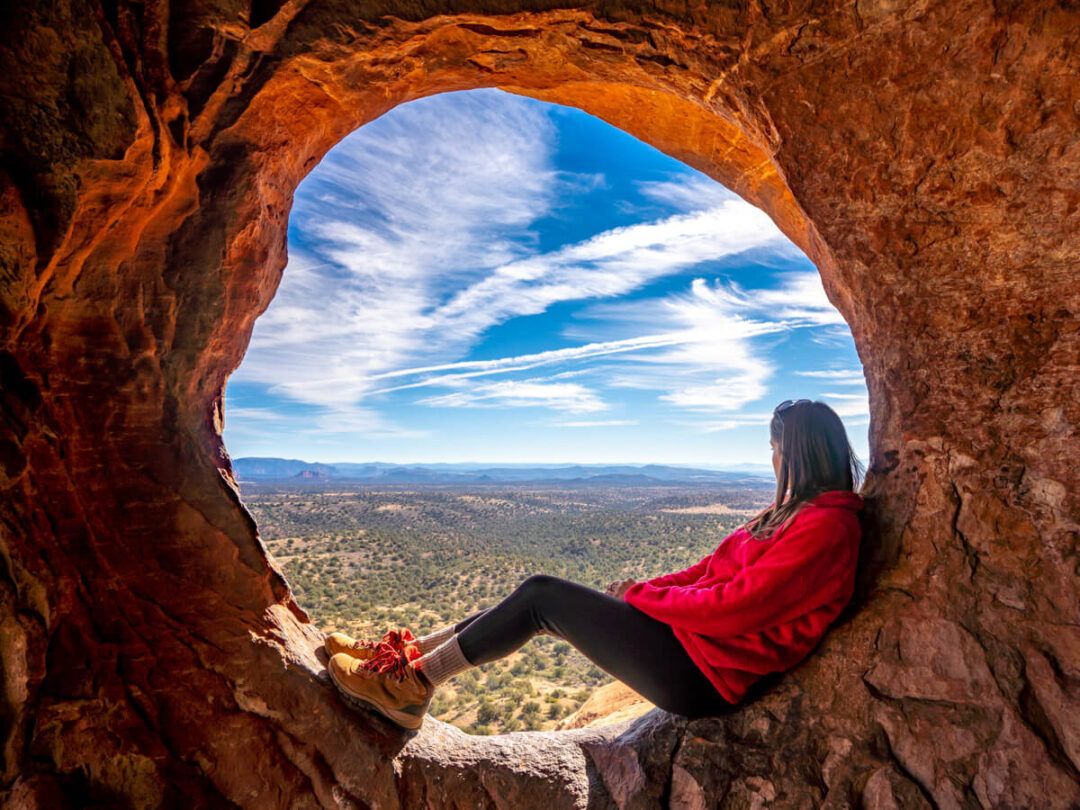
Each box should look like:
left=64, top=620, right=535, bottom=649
left=454, top=575, right=733, bottom=718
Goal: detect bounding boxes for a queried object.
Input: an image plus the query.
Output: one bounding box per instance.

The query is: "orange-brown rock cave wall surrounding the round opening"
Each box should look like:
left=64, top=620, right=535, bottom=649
left=0, top=0, right=1080, bottom=808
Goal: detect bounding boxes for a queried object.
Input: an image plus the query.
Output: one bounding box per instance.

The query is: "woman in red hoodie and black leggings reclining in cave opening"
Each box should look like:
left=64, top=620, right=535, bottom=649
left=326, top=400, right=863, bottom=729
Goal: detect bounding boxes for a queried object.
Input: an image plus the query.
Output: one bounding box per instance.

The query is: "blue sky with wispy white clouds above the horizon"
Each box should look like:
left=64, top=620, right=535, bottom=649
left=225, top=90, right=869, bottom=468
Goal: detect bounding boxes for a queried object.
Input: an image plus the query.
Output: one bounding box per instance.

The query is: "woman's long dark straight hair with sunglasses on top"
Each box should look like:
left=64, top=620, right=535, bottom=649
left=746, top=400, right=865, bottom=540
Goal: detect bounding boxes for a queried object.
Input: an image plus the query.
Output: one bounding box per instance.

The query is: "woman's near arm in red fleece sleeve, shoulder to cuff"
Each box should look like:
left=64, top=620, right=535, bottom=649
left=623, top=511, right=859, bottom=637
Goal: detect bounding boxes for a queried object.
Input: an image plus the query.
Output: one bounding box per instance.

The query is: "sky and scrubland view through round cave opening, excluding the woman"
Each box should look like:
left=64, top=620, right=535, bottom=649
left=224, top=89, right=868, bottom=734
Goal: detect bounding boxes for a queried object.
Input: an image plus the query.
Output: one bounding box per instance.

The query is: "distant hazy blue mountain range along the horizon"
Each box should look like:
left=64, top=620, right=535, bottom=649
left=232, top=458, right=774, bottom=487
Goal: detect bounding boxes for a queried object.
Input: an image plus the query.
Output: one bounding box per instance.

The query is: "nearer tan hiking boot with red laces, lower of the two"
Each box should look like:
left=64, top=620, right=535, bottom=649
left=326, top=643, right=435, bottom=731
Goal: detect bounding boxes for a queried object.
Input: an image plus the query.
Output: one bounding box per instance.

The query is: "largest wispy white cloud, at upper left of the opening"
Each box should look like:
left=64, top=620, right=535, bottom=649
left=234, top=93, right=561, bottom=424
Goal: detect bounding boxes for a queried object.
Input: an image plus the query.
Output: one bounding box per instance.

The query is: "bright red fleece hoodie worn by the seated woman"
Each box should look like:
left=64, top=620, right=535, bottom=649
left=623, top=489, right=863, bottom=703
